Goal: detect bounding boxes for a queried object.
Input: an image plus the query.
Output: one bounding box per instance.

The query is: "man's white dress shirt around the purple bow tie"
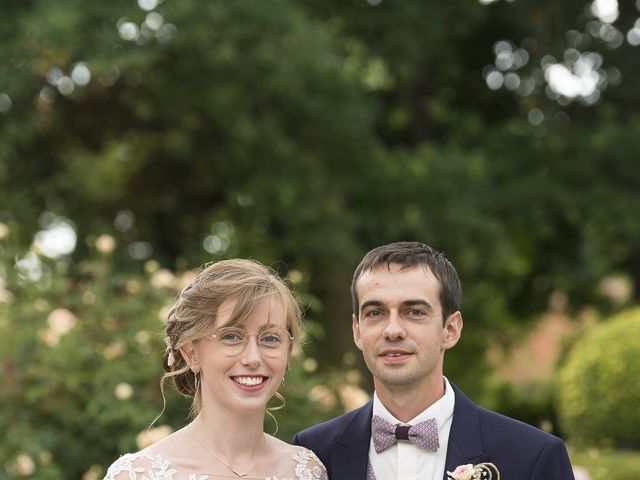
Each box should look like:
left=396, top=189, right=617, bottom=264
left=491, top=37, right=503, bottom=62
left=369, top=377, right=455, bottom=480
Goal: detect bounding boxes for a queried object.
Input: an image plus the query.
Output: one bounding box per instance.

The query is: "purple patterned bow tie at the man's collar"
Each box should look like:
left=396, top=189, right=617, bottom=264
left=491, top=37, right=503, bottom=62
left=371, top=415, right=440, bottom=453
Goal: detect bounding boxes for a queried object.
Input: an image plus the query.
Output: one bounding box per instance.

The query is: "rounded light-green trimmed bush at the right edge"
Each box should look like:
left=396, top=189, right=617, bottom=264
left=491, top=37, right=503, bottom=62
left=558, top=308, right=640, bottom=448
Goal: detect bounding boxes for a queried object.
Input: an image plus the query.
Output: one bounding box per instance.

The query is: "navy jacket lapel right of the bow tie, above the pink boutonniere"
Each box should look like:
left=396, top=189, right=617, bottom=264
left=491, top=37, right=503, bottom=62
left=443, top=384, right=489, bottom=480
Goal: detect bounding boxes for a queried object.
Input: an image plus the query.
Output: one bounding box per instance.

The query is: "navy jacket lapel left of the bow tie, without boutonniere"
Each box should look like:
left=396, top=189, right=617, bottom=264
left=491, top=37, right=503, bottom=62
left=331, top=402, right=373, bottom=480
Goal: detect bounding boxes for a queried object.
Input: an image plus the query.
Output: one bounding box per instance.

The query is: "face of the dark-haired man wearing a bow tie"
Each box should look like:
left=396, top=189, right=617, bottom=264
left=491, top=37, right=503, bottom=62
left=353, top=264, right=462, bottom=392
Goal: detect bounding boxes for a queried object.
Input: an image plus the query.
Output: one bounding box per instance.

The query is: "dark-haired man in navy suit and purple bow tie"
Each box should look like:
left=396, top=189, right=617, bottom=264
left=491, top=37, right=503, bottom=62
left=293, top=242, right=574, bottom=480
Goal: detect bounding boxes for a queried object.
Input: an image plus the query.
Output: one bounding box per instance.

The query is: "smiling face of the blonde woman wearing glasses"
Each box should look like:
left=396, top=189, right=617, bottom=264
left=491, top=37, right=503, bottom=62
left=195, top=297, right=291, bottom=414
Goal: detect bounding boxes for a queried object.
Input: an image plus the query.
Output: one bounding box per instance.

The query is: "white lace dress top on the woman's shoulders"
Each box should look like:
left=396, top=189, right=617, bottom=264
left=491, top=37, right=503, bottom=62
left=104, top=448, right=329, bottom=480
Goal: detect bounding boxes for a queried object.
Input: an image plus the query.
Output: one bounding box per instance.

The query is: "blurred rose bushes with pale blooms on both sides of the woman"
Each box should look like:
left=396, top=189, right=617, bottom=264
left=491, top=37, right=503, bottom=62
left=0, top=232, right=366, bottom=480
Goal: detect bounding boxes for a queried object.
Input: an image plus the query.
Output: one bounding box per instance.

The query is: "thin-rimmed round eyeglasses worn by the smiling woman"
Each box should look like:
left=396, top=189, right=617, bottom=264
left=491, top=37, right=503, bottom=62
left=208, top=327, right=293, bottom=357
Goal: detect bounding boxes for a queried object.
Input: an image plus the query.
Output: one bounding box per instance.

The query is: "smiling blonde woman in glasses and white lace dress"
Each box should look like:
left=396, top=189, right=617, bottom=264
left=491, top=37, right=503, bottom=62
left=105, top=259, right=328, bottom=480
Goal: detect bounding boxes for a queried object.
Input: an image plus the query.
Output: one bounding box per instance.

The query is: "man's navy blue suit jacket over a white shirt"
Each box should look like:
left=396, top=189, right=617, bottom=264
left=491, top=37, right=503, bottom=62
left=293, top=385, right=574, bottom=480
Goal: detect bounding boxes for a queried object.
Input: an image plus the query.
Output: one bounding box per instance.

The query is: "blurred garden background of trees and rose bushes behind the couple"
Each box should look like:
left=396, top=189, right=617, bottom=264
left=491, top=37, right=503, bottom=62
left=0, top=0, right=640, bottom=480
